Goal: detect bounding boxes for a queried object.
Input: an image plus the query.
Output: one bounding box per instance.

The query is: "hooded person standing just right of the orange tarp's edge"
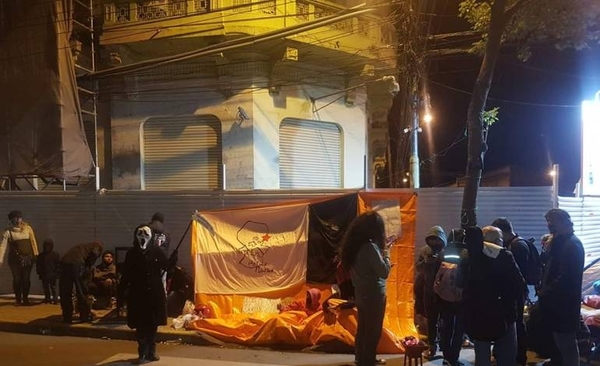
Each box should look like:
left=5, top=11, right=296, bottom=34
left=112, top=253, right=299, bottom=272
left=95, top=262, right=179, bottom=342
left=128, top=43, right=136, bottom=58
left=414, top=226, right=446, bottom=359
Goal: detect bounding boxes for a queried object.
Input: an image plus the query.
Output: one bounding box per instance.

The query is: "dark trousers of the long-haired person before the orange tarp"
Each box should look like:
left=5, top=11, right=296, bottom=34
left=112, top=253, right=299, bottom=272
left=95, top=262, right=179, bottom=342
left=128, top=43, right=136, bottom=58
left=354, top=294, right=386, bottom=366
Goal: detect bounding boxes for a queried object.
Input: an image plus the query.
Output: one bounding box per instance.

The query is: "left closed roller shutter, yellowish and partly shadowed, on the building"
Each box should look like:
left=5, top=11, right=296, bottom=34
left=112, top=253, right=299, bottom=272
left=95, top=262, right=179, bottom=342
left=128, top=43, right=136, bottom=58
left=142, top=116, right=222, bottom=190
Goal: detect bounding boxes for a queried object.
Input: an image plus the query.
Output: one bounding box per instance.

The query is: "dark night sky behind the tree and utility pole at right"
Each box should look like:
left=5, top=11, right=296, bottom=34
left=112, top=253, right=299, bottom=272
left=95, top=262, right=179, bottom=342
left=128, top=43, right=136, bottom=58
left=412, top=1, right=600, bottom=195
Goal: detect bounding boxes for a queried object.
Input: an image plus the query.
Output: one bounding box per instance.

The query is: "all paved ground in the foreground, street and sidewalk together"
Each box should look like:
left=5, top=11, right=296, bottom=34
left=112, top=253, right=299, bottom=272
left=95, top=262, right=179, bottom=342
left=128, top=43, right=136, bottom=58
left=0, top=296, right=600, bottom=366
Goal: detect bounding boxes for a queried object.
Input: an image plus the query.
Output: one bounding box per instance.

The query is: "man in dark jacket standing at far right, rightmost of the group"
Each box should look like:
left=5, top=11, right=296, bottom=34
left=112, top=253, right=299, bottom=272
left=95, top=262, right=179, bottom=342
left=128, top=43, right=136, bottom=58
left=538, top=209, right=585, bottom=366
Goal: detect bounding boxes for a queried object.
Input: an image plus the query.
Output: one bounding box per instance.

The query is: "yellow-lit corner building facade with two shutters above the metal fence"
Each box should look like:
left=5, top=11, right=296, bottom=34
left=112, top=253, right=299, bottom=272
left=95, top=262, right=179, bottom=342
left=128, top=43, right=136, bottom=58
left=96, top=0, right=397, bottom=190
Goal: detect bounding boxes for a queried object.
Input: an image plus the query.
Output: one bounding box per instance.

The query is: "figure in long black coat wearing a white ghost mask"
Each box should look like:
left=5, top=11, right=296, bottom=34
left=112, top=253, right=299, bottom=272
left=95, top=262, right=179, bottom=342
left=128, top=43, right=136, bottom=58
left=119, top=225, right=167, bottom=364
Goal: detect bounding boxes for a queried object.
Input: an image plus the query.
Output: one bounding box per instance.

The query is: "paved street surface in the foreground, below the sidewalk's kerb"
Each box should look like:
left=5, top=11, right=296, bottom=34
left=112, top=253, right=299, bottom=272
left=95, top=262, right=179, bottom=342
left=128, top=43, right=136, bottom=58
left=0, top=332, right=454, bottom=366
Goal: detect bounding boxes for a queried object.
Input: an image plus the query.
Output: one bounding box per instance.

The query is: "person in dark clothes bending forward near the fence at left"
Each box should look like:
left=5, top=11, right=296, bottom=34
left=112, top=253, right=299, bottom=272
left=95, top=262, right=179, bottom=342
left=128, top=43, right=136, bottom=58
left=59, top=242, right=103, bottom=323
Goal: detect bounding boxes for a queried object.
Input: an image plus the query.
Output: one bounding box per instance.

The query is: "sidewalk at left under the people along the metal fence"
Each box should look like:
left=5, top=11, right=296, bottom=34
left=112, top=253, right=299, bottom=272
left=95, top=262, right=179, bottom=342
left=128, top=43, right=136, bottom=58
left=0, top=295, right=223, bottom=346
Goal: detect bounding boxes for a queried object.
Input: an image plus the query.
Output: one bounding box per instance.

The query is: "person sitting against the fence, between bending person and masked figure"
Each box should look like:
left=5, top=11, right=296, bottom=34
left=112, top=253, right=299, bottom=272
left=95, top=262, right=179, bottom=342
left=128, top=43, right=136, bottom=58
left=88, top=250, right=117, bottom=308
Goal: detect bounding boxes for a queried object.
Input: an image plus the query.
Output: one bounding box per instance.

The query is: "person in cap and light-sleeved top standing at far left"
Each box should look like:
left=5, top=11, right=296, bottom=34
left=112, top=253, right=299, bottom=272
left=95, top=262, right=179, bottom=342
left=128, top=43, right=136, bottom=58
left=0, top=210, right=38, bottom=306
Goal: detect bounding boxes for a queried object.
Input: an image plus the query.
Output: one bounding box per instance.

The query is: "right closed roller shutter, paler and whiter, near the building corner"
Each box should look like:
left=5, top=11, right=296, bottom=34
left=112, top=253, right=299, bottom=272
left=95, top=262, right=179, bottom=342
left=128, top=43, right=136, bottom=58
left=279, top=118, right=342, bottom=188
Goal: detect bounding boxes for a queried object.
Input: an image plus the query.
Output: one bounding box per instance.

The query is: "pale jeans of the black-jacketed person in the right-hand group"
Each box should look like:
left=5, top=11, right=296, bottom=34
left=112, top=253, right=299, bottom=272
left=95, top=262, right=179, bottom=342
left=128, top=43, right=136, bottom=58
left=473, top=322, right=517, bottom=366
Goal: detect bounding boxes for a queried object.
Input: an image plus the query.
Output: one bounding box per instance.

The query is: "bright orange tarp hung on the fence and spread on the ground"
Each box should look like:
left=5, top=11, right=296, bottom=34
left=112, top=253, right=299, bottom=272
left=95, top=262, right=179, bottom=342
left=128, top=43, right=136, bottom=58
left=187, top=191, right=417, bottom=353
